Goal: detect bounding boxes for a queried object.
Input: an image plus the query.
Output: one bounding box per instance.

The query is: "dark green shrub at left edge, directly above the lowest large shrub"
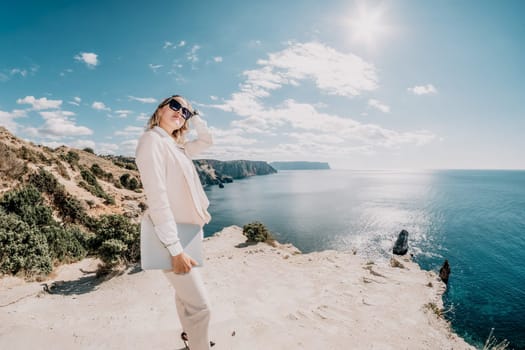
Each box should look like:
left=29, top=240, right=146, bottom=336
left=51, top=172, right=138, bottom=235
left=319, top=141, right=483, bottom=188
left=0, top=185, right=55, bottom=226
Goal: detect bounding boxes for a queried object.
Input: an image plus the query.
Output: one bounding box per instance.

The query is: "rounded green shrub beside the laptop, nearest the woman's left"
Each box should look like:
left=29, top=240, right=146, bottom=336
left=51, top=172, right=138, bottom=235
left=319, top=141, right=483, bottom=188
left=88, top=214, right=140, bottom=267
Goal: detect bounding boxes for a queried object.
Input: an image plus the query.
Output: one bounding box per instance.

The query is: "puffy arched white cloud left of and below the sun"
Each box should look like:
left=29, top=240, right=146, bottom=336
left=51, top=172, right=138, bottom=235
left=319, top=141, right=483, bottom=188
left=213, top=42, right=378, bottom=116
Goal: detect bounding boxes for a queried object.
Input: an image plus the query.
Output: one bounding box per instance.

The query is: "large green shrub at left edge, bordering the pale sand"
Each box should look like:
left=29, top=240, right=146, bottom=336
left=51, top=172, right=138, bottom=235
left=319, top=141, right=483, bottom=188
left=0, top=210, right=52, bottom=277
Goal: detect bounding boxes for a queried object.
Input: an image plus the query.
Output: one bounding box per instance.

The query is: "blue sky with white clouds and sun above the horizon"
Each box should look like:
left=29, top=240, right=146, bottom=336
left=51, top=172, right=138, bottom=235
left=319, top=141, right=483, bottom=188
left=0, top=0, right=525, bottom=169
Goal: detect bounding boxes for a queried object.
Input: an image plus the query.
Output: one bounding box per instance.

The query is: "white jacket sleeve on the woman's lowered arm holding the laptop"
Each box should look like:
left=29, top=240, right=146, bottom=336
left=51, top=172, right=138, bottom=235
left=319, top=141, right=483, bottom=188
left=135, top=132, right=183, bottom=255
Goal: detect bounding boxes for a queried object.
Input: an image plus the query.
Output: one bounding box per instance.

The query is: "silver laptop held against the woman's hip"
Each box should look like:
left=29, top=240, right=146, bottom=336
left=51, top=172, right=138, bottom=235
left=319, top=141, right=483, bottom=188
left=140, top=215, right=204, bottom=270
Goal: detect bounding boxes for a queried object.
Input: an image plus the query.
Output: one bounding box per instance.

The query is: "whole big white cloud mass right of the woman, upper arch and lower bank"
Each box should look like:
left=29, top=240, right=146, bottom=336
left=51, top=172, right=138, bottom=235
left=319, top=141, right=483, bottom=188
left=207, top=42, right=436, bottom=159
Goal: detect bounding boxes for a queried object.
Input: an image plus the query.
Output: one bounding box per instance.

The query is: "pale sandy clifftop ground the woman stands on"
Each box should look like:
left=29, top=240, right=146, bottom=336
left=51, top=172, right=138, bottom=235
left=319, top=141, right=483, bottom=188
left=0, top=226, right=474, bottom=350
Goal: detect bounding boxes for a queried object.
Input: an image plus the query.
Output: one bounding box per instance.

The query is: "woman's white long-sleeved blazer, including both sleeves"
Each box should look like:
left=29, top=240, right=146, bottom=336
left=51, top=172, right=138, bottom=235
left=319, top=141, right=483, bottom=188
left=135, top=115, right=213, bottom=255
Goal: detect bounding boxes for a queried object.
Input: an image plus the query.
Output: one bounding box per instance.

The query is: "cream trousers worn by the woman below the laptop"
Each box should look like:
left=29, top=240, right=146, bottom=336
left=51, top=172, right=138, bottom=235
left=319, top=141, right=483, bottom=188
left=163, top=267, right=210, bottom=350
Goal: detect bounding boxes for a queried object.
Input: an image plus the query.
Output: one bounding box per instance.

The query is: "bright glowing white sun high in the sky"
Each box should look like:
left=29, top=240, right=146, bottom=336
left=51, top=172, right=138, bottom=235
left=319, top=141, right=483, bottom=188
left=346, top=3, right=387, bottom=46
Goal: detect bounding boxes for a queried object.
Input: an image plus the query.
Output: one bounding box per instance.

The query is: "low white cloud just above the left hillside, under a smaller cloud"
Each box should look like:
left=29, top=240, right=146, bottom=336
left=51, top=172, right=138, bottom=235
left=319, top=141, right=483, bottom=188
left=36, top=111, right=93, bottom=138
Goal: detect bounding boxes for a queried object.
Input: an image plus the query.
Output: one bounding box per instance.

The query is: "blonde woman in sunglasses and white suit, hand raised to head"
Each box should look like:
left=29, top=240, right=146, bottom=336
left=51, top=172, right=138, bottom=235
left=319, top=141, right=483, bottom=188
left=136, top=95, right=214, bottom=350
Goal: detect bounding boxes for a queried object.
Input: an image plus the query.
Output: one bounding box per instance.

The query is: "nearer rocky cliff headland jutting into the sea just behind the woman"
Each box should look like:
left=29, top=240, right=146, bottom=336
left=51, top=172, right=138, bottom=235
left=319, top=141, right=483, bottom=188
left=193, top=159, right=277, bottom=185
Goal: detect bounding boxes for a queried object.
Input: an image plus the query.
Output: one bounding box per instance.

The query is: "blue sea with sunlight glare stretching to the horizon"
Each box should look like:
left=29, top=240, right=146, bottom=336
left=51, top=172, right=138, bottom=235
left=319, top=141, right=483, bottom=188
left=205, top=170, right=525, bottom=349
